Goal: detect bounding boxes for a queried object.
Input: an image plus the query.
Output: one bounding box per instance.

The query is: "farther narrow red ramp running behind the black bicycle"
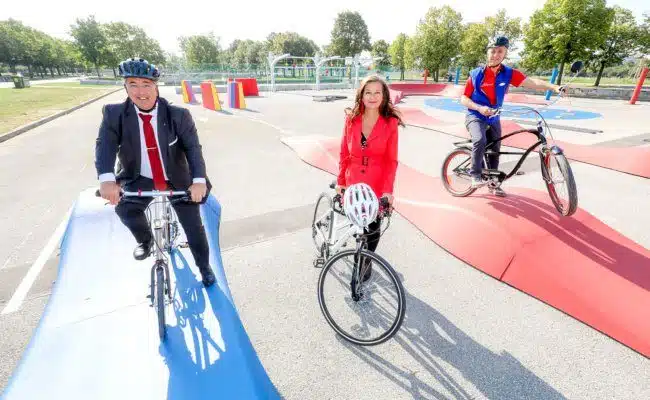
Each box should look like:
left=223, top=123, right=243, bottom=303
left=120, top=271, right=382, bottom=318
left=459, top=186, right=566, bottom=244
left=400, top=107, right=650, bottom=178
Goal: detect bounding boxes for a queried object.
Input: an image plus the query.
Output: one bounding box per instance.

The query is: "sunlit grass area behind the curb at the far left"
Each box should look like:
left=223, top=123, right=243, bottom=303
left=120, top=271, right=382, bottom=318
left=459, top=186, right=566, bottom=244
left=0, top=82, right=115, bottom=134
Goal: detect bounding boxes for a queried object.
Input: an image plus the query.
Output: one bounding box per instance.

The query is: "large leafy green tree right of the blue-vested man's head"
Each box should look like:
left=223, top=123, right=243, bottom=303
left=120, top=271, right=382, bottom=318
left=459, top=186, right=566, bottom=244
left=522, top=0, right=612, bottom=84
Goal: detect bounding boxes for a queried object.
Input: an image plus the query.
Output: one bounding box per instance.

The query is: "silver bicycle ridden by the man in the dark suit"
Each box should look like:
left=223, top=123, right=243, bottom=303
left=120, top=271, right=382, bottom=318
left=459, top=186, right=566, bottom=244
left=95, top=190, right=191, bottom=340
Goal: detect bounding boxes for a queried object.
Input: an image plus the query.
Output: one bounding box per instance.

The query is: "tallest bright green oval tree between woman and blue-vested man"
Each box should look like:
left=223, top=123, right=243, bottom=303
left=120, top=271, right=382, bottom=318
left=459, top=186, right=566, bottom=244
left=414, top=5, right=463, bottom=82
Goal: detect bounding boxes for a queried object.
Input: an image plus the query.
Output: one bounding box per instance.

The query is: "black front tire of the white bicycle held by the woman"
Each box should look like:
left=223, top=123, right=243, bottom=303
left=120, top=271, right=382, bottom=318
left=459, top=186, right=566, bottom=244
left=318, top=249, right=406, bottom=346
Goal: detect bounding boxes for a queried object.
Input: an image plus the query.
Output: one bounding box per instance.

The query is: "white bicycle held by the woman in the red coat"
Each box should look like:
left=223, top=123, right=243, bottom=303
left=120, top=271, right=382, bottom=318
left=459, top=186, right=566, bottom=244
left=312, top=182, right=406, bottom=345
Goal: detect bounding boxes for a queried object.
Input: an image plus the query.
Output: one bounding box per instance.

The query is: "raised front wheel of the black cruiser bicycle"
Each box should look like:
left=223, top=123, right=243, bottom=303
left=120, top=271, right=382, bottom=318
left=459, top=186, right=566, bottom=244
left=542, top=151, right=578, bottom=217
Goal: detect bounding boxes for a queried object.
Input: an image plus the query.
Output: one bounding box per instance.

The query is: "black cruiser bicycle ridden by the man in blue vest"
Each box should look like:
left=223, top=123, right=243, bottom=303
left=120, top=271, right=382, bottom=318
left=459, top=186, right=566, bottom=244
left=441, top=61, right=582, bottom=217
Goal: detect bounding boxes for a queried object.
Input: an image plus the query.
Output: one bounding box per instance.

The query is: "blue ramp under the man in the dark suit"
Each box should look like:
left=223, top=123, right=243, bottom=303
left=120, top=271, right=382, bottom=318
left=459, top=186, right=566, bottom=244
left=2, top=188, right=280, bottom=400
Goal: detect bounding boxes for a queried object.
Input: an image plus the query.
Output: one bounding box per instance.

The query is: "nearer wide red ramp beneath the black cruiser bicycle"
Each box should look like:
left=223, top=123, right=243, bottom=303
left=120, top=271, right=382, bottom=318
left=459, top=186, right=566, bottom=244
left=283, top=136, right=650, bottom=357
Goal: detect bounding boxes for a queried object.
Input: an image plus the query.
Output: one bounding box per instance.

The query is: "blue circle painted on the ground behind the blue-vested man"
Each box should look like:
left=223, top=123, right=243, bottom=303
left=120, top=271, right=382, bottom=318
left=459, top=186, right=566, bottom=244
left=424, top=97, right=602, bottom=120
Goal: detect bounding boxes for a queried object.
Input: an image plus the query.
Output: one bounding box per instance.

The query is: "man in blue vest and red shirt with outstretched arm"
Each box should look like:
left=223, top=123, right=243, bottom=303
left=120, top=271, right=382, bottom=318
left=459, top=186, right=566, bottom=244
left=460, top=36, right=564, bottom=197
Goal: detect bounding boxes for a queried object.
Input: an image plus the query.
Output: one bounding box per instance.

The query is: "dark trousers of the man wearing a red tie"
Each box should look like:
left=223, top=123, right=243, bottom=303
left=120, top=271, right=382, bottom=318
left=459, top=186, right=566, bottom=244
left=115, top=177, right=210, bottom=270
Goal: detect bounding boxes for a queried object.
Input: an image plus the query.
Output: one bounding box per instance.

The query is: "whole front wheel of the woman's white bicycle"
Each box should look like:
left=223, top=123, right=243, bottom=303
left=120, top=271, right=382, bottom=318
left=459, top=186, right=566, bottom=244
left=318, top=249, right=406, bottom=346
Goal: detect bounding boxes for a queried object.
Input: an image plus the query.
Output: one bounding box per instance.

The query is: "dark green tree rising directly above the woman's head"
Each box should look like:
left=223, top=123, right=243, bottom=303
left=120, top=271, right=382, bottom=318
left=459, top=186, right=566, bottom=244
left=327, top=11, right=370, bottom=57
